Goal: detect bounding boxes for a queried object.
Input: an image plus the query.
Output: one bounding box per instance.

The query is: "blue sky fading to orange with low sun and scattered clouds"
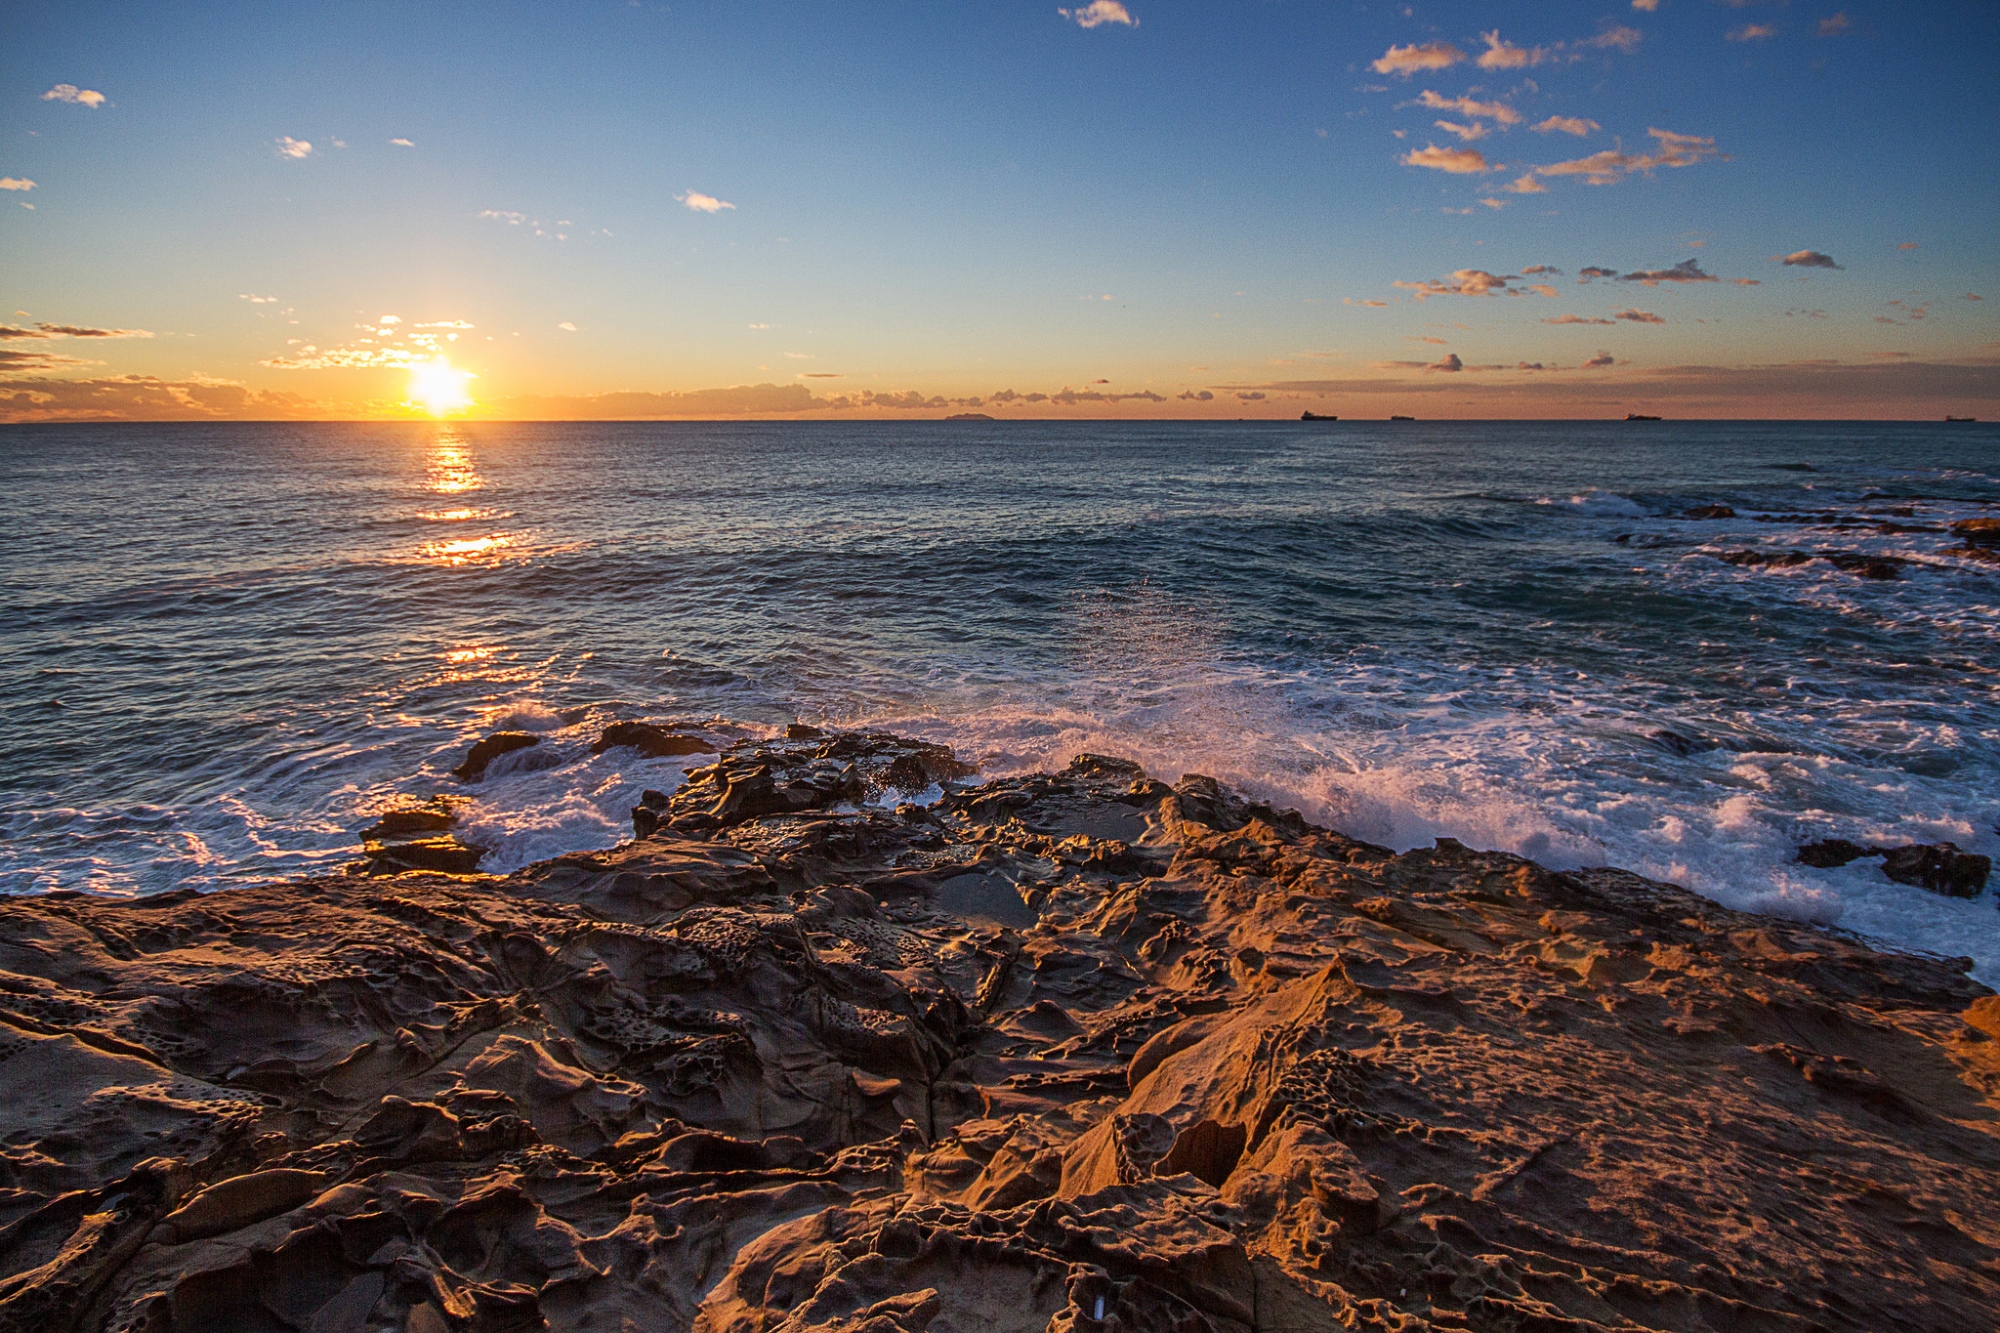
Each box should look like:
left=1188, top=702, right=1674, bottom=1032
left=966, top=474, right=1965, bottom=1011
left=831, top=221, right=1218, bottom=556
left=0, top=0, right=2000, bottom=420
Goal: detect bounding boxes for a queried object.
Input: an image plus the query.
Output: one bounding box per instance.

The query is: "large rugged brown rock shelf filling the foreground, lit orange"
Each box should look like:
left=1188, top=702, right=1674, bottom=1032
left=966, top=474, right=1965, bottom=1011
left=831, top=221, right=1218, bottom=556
left=0, top=731, right=2000, bottom=1333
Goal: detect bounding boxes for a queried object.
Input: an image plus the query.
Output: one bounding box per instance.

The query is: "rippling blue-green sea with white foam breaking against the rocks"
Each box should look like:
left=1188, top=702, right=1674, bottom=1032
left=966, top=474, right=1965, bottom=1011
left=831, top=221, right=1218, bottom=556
left=0, top=420, right=2000, bottom=985
